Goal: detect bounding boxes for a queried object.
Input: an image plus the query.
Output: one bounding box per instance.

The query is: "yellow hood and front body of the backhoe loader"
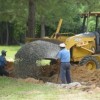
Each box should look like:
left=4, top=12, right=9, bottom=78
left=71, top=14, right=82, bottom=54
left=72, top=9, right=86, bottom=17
left=65, top=33, right=96, bottom=62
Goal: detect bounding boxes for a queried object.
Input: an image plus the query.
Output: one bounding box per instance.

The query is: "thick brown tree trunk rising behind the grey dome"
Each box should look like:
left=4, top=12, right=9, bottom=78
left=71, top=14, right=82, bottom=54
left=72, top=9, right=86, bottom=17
left=26, top=0, right=35, bottom=38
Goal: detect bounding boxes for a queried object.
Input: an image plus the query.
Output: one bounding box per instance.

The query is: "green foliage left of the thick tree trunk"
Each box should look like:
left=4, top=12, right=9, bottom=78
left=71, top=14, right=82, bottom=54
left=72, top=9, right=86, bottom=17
left=0, top=0, right=28, bottom=42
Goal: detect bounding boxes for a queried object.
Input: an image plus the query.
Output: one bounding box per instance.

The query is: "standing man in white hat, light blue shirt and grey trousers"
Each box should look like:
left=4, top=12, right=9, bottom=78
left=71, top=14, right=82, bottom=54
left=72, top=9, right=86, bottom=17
left=57, top=43, right=71, bottom=84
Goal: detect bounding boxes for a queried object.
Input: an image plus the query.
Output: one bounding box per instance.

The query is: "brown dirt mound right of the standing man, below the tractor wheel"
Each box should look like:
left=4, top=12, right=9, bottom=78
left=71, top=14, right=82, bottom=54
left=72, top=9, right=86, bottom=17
left=71, top=66, right=100, bottom=86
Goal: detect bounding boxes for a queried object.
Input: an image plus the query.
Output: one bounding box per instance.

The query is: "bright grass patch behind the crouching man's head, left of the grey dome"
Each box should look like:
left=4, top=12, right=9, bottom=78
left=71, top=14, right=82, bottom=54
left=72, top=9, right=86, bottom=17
left=0, top=46, right=21, bottom=59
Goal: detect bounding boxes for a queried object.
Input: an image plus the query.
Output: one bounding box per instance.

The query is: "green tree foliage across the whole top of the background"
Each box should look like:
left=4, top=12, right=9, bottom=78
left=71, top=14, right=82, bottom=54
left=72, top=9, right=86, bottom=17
left=0, top=0, right=100, bottom=41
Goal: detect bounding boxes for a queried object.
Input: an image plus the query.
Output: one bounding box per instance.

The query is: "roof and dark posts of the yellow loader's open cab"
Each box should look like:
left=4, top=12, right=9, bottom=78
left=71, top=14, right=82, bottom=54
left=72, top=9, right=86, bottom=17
left=81, top=12, right=100, bottom=53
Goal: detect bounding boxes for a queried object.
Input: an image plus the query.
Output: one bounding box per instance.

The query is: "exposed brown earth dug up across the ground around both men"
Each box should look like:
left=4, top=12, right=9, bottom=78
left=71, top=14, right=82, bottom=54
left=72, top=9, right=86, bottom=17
left=6, top=62, right=100, bottom=94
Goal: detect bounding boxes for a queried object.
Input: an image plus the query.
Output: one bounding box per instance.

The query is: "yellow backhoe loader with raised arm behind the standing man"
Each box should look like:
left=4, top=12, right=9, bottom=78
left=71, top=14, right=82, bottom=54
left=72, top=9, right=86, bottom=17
left=26, top=12, right=100, bottom=70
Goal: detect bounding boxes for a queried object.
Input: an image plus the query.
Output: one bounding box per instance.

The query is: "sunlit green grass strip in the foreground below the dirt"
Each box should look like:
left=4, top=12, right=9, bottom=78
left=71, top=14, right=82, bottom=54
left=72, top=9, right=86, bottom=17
left=0, top=77, right=100, bottom=100
